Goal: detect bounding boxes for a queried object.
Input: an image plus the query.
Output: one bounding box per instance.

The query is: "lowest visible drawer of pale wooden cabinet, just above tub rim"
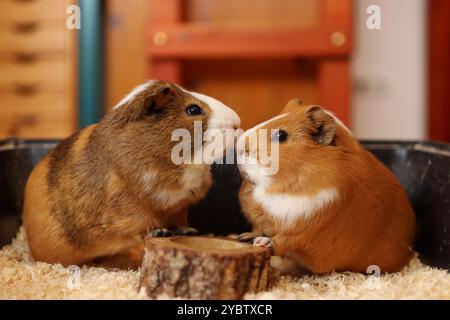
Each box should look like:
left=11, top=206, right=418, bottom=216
left=0, top=93, right=75, bottom=138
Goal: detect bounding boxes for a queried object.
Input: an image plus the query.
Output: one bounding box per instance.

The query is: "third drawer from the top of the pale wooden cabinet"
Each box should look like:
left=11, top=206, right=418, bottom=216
left=0, top=60, right=70, bottom=91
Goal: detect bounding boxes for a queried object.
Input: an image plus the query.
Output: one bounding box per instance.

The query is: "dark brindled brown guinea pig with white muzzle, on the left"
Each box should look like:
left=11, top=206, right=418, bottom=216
left=23, top=80, right=240, bottom=266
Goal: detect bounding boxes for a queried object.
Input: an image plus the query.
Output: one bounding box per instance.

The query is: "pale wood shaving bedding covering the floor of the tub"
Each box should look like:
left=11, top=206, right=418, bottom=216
left=0, top=228, right=450, bottom=299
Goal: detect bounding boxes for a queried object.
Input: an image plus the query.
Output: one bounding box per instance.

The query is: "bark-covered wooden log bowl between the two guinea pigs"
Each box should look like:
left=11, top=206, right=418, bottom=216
left=140, top=236, right=271, bottom=299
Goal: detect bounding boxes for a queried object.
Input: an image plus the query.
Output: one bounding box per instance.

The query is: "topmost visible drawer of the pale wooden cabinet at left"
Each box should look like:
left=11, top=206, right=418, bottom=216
left=0, top=0, right=70, bottom=23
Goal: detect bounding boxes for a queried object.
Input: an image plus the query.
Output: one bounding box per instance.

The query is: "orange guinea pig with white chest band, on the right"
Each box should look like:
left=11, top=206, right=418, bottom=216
left=238, top=99, right=415, bottom=273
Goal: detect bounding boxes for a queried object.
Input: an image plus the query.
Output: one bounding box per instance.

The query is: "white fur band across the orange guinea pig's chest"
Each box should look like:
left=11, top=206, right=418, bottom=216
left=253, top=186, right=338, bottom=227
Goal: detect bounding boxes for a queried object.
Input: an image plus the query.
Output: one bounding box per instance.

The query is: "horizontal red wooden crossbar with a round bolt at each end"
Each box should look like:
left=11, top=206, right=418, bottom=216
left=149, top=24, right=350, bottom=58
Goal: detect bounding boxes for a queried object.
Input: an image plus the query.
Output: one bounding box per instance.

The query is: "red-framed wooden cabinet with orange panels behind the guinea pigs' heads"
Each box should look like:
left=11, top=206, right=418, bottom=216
left=147, top=0, right=353, bottom=128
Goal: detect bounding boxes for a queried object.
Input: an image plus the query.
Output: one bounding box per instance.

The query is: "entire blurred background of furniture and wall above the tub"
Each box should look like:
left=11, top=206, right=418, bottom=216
left=0, top=0, right=450, bottom=141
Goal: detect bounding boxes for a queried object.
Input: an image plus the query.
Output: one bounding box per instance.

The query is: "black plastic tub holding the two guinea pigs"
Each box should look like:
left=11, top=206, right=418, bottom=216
left=0, top=140, right=450, bottom=270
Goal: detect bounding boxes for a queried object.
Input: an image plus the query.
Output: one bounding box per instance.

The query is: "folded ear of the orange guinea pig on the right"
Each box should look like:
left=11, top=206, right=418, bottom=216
left=305, top=106, right=336, bottom=146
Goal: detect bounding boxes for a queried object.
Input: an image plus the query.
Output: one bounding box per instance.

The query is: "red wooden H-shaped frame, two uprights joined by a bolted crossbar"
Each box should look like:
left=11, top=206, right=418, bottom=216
left=148, top=0, right=353, bottom=124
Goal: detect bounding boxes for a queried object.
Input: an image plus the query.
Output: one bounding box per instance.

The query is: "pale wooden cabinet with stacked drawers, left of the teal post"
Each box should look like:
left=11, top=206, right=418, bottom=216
left=0, top=0, right=77, bottom=138
